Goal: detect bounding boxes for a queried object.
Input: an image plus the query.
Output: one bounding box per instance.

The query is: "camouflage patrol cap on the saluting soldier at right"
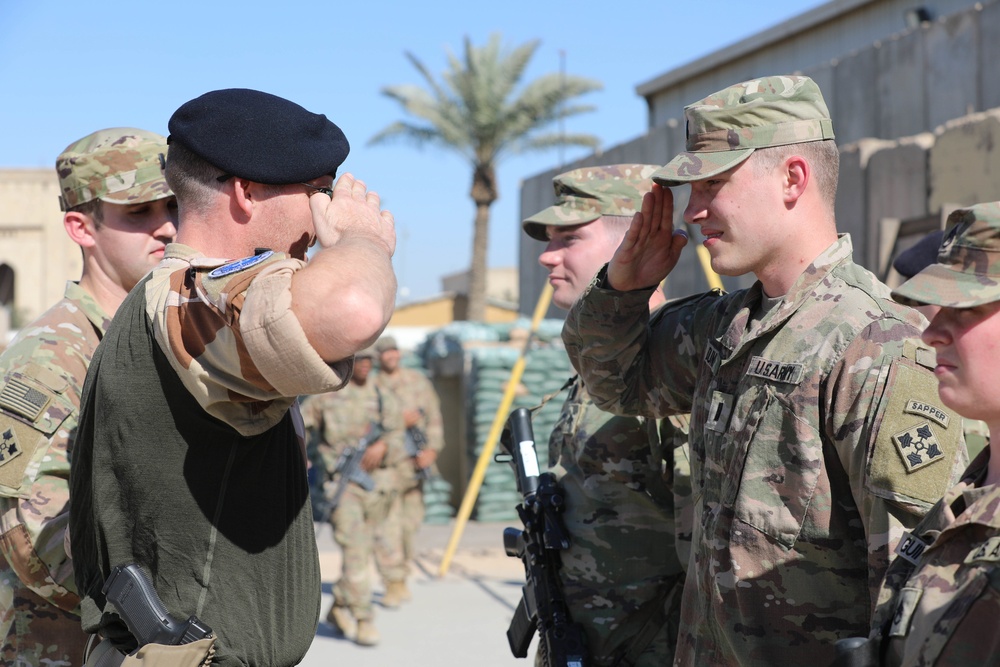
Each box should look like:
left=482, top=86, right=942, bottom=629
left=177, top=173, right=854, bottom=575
left=653, top=76, right=833, bottom=187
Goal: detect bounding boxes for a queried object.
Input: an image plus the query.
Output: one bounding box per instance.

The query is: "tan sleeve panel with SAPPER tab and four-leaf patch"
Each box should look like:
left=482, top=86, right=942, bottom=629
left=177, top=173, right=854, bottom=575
left=869, top=360, right=962, bottom=503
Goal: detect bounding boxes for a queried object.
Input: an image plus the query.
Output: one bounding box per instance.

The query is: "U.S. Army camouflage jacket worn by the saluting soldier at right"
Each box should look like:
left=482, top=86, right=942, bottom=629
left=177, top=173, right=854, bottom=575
left=563, top=236, right=967, bottom=666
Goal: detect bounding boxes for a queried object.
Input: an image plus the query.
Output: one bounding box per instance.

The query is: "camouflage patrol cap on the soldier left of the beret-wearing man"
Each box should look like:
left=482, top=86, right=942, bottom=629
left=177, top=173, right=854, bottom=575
left=56, top=127, right=173, bottom=211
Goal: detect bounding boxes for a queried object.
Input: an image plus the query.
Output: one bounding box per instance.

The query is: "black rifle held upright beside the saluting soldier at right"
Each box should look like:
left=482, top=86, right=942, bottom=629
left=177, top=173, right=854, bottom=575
left=496, top=408, right=590, bottom=667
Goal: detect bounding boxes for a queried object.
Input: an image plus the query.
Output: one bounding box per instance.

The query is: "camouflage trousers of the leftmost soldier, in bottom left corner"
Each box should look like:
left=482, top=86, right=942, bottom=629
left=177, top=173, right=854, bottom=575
left=0, top=558, right=89, bottom=667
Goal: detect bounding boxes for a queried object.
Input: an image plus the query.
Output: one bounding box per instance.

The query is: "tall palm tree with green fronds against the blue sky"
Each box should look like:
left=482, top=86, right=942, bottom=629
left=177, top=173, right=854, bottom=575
left=368, top=34, right=601, bottom=320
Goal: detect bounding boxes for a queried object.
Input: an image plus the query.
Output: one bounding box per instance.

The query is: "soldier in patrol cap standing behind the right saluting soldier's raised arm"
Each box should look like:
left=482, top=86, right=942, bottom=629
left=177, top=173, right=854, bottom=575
left=524, top=164, right=690, bottom=667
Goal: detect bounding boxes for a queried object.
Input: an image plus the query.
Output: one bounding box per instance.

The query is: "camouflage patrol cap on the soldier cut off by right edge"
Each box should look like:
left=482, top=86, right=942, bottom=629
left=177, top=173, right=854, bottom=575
left=892, top=202, right=1000, bottom=308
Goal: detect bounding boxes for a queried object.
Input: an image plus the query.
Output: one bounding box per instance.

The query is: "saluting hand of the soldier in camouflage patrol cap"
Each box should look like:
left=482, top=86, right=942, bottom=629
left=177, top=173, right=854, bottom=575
left=608, top=183, right=687, bottom=292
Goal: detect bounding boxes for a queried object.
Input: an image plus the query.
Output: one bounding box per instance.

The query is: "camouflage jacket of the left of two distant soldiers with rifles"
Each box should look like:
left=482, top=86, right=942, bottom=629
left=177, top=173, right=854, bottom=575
left=302, top=376, right=413, bottom=491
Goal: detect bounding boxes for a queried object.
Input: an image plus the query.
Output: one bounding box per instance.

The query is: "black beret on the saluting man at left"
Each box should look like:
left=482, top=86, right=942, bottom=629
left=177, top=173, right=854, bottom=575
left=167, top=88, right=351, bottom=185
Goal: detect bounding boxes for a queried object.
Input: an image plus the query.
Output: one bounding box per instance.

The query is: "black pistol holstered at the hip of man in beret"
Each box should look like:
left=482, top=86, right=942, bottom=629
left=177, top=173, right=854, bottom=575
left=87, top=563, right=214, bottom=667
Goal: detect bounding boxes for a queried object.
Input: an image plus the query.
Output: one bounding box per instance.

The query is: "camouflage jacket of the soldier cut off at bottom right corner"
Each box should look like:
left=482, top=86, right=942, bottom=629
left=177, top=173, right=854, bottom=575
left=873, top=449, right=1000, bottom=667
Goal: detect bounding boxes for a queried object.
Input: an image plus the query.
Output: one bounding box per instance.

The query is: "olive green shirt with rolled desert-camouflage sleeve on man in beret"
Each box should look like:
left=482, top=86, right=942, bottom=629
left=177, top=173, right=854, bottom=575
left=70, top=243, right=353, bottom=667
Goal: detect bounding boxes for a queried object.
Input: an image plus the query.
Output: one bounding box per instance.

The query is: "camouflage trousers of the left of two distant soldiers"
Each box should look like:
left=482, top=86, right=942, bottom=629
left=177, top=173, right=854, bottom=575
left=330, top=484, right=396, bottom=620
